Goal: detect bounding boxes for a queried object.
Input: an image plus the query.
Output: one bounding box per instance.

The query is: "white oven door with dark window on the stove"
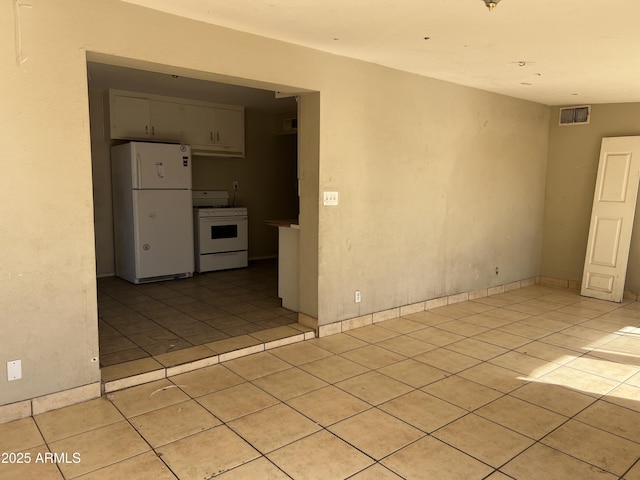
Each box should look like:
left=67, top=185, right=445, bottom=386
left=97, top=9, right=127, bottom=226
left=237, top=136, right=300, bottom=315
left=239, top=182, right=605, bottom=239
left=198, top=216, right=249, bottom=255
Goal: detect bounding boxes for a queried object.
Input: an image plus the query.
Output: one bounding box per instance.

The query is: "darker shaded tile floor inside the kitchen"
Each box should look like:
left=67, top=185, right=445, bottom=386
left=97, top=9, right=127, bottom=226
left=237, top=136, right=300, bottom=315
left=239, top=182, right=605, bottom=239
left=98, top=259, right=297, bottom=367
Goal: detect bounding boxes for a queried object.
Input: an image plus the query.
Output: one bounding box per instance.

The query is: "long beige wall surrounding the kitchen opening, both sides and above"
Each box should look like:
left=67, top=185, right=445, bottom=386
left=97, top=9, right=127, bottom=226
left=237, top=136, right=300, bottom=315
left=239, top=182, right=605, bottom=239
left=0, top=0, right=548, bottom=404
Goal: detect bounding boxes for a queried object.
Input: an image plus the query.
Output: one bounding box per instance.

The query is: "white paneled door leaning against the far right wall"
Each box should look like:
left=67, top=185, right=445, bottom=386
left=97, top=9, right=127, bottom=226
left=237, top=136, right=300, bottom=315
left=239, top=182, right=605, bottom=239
left=581, top=137, right=640, bottom=302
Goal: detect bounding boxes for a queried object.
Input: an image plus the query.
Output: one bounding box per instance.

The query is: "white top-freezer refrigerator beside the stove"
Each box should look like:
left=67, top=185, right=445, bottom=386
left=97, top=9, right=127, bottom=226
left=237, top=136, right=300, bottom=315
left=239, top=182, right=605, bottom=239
left=111, top=142, right=194, bottom=283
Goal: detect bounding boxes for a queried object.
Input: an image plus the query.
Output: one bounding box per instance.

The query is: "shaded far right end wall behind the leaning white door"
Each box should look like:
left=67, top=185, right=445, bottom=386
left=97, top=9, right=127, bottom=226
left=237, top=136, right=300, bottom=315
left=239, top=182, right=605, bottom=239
left=541, top=103, right=640, bottom=292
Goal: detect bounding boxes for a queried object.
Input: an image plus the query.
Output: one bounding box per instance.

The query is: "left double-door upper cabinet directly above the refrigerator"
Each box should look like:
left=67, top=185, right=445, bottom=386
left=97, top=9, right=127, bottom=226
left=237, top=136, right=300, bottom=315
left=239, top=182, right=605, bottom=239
left=109, top=91, right=184, bottom=142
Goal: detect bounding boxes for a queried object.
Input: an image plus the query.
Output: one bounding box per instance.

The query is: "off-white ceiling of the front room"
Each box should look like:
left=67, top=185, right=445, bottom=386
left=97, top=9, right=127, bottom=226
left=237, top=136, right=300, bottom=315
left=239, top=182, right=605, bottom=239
left=119, top=0, right=640, bottom=105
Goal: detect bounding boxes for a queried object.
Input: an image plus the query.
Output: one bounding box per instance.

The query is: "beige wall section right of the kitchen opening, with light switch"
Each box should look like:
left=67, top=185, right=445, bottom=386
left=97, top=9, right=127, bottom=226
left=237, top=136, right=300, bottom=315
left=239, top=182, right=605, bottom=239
left=319, top=65, right=548, bottom=323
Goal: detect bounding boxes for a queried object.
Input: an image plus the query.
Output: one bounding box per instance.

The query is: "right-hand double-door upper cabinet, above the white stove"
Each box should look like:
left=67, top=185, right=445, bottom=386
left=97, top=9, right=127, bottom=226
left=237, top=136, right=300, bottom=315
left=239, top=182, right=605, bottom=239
left=184, top=104, right=244, bottom=157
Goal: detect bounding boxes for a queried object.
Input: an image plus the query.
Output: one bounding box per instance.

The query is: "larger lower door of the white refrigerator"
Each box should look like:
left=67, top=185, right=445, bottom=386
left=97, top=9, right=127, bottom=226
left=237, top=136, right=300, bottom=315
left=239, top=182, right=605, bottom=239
left=133, top=190, right=194, bottom=279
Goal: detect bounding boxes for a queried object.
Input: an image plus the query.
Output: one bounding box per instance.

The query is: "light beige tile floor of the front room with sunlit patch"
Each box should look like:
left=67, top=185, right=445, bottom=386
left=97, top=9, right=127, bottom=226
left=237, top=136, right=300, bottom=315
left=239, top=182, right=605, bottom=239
left=0, top=285, right=640, bottom=480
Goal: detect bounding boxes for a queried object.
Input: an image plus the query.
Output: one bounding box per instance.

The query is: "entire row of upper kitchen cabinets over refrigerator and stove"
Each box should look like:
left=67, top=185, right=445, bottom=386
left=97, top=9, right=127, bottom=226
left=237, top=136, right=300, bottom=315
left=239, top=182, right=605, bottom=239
left=108, top=90, right=244, bottom=157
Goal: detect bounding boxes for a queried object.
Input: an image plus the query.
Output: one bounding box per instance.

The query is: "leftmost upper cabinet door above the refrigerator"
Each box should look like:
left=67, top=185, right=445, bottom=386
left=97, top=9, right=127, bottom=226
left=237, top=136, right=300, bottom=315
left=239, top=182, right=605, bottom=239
left=110, top=95, right=151, bottom=139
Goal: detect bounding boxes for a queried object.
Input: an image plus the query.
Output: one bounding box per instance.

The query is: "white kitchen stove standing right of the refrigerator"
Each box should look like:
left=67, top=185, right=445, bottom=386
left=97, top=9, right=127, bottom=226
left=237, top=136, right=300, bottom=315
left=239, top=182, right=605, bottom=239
left=193, top=190, right=249, bottom=273
